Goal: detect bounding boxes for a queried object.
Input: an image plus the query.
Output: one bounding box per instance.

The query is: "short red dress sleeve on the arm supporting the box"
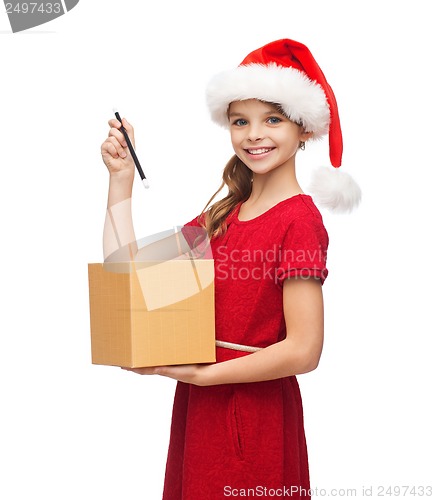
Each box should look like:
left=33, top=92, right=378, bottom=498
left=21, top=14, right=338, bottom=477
left=277, top=216, right=328, bottom=284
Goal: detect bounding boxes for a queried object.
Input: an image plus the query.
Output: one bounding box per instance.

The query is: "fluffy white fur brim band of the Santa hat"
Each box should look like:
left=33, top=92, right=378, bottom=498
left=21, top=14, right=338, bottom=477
left=206, top=63, right=330, bottom=138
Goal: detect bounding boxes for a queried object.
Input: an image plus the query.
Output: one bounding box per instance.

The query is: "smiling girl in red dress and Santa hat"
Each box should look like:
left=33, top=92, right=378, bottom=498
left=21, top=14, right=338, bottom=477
left=101, top=39, right=360, bottom=500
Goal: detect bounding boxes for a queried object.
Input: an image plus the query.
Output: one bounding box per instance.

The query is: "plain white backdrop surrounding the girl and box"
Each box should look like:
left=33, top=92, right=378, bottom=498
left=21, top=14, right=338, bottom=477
left=0, top=0, right=434, bottom=500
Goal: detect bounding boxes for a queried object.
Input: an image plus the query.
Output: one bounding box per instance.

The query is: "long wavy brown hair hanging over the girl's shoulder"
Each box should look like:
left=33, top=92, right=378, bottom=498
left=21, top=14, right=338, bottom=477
left=199, top=155, right=253, bottom=239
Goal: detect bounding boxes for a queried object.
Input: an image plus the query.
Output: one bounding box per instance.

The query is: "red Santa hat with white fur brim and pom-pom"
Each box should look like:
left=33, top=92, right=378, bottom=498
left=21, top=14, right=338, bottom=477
left=206, top=39, right=361, bottom=212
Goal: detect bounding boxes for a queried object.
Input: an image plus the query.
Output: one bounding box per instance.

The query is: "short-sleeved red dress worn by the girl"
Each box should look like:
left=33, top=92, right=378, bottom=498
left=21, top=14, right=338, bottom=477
left=163, top=195, right=328, bottom=500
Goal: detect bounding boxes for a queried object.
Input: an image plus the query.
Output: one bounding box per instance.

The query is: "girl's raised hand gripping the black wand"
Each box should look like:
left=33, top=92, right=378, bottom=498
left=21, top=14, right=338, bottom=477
left=101, top=118, right=135, bottom=178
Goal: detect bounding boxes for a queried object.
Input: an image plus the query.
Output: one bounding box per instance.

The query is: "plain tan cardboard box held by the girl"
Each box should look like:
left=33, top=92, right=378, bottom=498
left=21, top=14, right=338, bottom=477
left=88, top=259, right=216, bottom=368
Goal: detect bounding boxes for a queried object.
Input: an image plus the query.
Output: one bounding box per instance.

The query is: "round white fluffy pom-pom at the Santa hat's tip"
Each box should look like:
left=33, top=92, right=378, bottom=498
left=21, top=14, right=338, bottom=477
left=309, top=167, right=362, bottom=213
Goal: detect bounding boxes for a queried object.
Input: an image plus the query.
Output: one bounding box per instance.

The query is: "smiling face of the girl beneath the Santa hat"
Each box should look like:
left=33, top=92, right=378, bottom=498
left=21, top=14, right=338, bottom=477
left=228, top=99, right=312, bottom=174
